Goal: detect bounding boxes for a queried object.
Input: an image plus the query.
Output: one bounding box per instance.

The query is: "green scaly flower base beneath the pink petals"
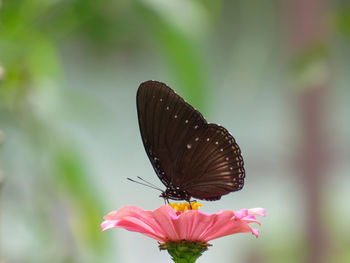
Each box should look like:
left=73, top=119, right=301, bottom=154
left=159, top=240, right=211, bottom=263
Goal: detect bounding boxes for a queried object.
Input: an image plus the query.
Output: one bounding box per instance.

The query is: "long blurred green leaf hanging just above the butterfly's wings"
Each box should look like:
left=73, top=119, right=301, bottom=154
left=135, top=1, right=209, bottom=112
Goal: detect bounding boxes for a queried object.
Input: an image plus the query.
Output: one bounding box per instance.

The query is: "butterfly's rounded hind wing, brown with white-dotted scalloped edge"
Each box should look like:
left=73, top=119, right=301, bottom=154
left=182, top=124, right=245, bottom=200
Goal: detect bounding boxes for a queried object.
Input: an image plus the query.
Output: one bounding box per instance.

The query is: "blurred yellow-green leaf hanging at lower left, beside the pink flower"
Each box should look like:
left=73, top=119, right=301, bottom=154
left=53, top=147, right=107, bottom=258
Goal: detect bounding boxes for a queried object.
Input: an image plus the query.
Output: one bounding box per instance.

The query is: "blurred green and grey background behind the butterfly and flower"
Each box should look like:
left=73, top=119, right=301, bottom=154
left=0, top=0, right=350, bottom=263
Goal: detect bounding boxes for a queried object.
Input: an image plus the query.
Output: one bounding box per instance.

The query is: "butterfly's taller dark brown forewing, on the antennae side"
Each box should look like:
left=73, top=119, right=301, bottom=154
left=136, top=81, right=206, bottom=186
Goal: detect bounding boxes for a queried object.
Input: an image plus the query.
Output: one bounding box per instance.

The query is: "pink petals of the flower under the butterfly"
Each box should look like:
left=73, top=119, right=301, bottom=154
left=101, top=205, right=265, bottom=243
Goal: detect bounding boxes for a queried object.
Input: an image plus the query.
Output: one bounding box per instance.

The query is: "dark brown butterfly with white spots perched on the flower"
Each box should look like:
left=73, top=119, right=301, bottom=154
left=136, top=80, right=245, bottom=202
